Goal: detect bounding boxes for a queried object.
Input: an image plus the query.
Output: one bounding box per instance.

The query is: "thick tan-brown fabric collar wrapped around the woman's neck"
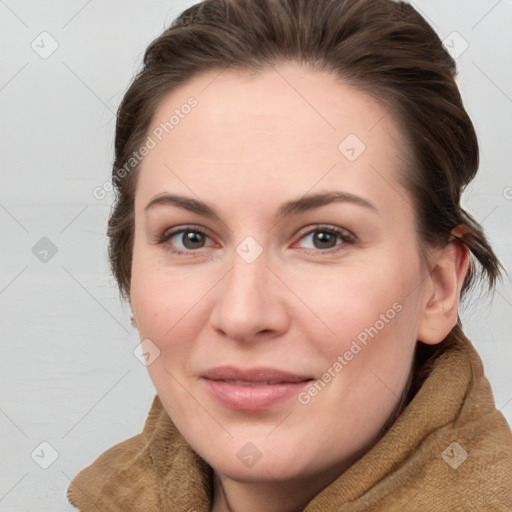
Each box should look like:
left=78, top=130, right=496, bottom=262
left=67, top=334, right=512, bottom=512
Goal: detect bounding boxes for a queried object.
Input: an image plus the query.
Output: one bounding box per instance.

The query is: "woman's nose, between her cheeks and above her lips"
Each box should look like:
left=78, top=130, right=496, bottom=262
left=210, top=245, right=289, bottom=342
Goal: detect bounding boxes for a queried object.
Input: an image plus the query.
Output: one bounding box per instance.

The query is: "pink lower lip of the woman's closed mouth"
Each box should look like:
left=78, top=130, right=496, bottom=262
left=202, top=379, right=311, bottom=411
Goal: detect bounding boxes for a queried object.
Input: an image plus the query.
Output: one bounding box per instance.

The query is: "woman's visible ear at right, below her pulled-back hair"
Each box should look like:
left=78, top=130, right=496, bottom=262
left=417, top=225, right=469, bottom=345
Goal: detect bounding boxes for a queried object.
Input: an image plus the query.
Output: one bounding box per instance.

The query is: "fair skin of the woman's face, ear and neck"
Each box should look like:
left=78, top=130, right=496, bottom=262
left=130, top=63, right=468, bottom=512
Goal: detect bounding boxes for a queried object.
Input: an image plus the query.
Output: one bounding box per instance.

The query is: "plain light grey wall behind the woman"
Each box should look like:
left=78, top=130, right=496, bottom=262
left=0, top=0, right=512, bottom=512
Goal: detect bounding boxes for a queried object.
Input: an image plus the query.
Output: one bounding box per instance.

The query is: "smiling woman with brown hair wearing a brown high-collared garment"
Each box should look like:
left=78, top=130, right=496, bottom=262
left=68, top=0, right=512, bottom=512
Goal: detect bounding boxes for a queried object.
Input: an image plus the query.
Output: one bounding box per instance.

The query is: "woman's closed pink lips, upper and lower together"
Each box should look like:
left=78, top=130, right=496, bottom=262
left=201, top=366, right=313, bottom=411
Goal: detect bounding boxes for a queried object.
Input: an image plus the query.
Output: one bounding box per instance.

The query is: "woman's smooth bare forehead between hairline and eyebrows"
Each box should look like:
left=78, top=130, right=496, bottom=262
left=135, top=63, right=403, bottom=217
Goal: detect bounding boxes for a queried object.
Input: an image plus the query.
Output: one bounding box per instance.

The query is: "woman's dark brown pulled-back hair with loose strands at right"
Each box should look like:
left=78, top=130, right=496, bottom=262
left=108, top=0, right=501, bottom=418
